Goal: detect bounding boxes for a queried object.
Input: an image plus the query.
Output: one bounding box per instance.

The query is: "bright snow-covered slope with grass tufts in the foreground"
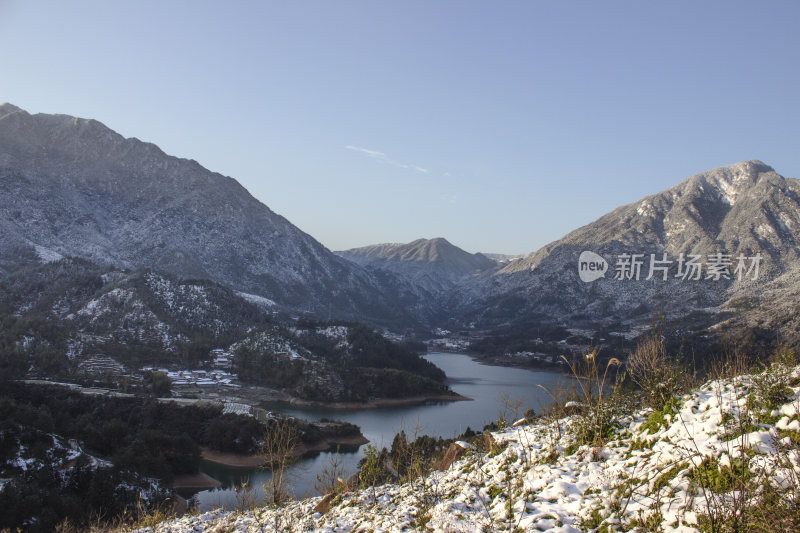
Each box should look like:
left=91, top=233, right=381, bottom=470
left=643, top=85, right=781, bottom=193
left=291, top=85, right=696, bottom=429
left=133, top=367, right=800, bottom=533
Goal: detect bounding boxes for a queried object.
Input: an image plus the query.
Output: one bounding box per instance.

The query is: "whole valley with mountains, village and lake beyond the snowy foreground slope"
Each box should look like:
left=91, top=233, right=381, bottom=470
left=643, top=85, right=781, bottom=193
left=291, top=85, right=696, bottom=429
left=0, top=104, right=800, bottom=531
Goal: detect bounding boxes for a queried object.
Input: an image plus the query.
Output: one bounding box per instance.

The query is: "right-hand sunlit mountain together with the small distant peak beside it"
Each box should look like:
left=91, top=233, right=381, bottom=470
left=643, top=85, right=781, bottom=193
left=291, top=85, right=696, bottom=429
left=337, top=160, right=800, bottom=340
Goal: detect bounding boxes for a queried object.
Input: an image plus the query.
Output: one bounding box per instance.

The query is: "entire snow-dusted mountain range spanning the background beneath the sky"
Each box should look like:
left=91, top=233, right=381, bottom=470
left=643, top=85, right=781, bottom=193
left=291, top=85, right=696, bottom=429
left=0, top=104, right=800, bottom=352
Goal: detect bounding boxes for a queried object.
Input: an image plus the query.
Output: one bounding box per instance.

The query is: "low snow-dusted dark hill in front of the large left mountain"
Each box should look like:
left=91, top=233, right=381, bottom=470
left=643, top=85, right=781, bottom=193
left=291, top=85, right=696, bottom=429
left=0, top=258, right=274, bottom=366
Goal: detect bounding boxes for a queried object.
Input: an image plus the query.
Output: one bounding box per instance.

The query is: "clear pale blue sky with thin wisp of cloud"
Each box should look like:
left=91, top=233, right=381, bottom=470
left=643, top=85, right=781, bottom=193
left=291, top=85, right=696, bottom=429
left=0, top=0, right=800, bottom=254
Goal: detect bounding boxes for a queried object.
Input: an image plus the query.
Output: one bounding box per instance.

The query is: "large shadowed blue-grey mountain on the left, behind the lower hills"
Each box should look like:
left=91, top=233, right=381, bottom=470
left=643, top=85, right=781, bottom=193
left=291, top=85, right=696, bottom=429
left=0, top=104, right=410, bottom=324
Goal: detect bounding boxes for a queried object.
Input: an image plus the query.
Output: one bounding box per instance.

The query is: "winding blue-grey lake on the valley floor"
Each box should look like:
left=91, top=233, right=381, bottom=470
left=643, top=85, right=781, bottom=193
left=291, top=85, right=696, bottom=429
left=181, top=353, right=569, bottom=510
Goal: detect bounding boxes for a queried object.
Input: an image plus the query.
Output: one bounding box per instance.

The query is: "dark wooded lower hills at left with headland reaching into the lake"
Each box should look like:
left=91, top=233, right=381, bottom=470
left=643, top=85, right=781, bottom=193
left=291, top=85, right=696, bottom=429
left=0, top=259, right=449, bottom=401
